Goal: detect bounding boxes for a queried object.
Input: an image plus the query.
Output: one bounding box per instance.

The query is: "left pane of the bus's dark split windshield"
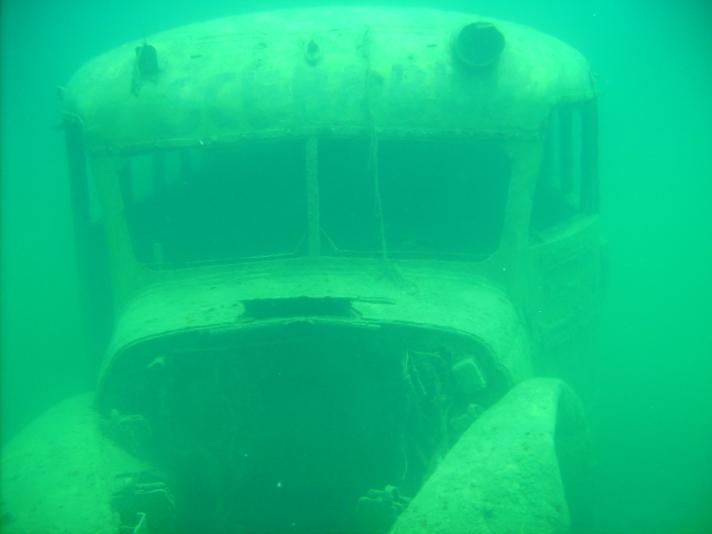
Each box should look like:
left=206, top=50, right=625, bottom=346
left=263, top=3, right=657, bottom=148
left=123, top=142, right=306, bottom=263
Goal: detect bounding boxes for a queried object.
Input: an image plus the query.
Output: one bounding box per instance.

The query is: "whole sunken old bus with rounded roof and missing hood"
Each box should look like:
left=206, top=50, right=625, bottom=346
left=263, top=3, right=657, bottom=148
left=2, top=7, right=601, bottom=534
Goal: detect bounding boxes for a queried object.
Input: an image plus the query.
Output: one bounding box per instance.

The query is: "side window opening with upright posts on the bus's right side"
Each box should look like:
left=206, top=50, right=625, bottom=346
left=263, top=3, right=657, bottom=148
left=531, top=101, right=598, bottom=235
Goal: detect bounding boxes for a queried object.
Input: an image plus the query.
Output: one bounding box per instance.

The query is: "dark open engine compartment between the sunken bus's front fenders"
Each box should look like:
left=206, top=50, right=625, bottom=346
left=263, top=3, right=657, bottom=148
left=102, top=320, right=506, bottom=532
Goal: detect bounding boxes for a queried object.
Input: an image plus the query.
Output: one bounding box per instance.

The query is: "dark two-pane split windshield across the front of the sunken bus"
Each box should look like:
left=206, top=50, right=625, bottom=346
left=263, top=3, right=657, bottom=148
left=122, top=138, right=510, bottom=264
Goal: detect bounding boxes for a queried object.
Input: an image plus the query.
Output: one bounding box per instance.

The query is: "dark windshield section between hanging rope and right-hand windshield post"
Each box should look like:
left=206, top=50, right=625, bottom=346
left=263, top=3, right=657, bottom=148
left=379, top=139, right=510, bottom=257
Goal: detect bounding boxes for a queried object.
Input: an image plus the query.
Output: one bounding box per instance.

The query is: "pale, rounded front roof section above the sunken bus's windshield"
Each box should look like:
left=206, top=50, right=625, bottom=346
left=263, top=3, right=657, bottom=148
left=63, top=7, right=595, bottom=151
